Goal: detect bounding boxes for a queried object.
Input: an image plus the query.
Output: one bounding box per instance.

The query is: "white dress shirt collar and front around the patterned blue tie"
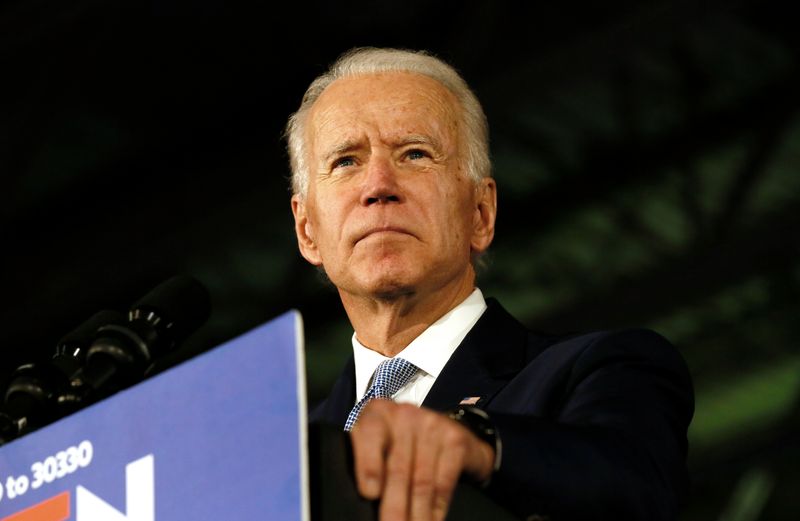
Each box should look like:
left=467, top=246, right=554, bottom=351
left=353, top=288, right=486, bottom=406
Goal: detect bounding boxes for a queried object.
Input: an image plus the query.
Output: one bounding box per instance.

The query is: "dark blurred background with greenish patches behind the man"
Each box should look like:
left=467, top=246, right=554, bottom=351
left=0, top=0, right=800, bottom=521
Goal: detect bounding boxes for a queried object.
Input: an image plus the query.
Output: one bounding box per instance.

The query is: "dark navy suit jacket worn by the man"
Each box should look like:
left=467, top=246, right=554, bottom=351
left=311, top=299, right=694, bottom=521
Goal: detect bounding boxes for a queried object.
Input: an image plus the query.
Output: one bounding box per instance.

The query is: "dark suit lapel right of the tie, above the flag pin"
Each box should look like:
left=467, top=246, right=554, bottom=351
left=422, top=299, right=527, bottom=411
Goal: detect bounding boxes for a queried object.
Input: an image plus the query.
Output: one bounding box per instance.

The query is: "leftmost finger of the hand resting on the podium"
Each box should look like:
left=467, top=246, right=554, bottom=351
left=350, top=400, right=391, bottom=499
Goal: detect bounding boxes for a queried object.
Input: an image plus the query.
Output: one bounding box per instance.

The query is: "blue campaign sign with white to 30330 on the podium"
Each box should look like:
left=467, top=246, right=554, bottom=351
left=0, top=311, right=309, bottom=521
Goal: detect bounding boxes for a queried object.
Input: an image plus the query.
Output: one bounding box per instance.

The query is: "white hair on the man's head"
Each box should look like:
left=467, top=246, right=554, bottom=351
left=285, top=47, right=492, bottom=197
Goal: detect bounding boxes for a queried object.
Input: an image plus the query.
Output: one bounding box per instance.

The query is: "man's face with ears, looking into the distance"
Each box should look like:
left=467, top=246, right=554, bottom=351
left=292, top=73, right=495, bottom=299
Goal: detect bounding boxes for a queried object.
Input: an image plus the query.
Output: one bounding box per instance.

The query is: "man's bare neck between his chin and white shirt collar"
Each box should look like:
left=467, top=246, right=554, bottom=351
left=339, top=277, right=475, bottom=357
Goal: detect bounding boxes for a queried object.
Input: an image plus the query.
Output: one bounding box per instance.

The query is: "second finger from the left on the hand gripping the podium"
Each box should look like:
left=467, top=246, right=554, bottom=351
left=380, top=404, right=420, bottom=521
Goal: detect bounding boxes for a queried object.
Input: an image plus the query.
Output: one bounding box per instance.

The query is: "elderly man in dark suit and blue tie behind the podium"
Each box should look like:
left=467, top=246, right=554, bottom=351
left=287, top=48, right=693, bottom=521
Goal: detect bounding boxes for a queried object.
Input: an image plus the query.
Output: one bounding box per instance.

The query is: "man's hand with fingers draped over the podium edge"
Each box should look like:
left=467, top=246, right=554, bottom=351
left=350, top=400, right=494, bottom=521
